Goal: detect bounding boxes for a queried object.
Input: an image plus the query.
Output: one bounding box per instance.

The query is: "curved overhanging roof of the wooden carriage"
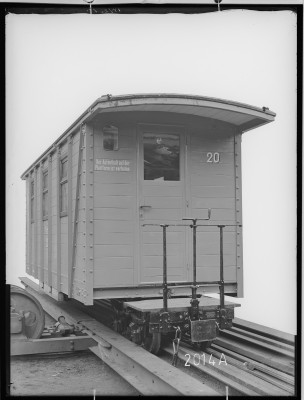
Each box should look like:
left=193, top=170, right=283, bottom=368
left=22, top=94, right=276, bottom=179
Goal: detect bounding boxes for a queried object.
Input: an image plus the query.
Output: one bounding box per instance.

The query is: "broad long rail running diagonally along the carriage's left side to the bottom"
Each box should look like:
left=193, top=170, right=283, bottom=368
left=20, top=278, right=218, bottom=396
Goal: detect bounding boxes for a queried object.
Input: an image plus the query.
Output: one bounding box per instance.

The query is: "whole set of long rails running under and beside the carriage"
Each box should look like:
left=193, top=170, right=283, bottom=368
left=18, top=279, right=295, bottom=396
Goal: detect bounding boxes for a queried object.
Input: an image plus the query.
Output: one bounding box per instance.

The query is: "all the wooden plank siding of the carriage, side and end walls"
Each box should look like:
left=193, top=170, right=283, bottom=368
left=22, top=108, right=243, bottom=305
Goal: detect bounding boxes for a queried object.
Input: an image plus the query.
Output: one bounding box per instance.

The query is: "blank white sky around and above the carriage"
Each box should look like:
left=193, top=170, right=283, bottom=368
left=6, top=10, right=296, bottom=334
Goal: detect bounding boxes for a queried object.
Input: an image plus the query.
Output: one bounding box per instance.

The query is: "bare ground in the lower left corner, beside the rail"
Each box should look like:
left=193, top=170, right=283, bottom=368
left=11, top=351, right=138, bottom=397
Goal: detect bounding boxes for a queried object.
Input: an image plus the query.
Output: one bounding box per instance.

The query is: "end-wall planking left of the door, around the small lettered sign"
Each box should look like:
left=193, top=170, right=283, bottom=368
left=94, top=118, right=137, bottom=287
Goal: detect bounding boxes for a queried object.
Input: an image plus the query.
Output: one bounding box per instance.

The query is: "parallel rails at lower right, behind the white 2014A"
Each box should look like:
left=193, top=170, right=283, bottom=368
left=164, top=318, right=295, bottom=396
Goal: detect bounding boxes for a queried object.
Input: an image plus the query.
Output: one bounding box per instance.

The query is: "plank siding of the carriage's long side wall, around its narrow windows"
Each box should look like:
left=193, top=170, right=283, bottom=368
left=22, top=132, right=86, bottom=295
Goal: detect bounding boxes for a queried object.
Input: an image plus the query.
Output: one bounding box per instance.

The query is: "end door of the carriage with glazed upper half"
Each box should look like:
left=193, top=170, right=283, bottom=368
left=138, top=124, right=189, bottom=284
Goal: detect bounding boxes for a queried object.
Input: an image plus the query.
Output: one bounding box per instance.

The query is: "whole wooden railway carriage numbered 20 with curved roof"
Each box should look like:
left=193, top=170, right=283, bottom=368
left=22, top=94, right=275, bottom=354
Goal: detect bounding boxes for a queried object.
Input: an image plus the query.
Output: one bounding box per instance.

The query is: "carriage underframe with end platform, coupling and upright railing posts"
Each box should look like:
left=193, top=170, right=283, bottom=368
left=112, top=220, right=239, bottom=354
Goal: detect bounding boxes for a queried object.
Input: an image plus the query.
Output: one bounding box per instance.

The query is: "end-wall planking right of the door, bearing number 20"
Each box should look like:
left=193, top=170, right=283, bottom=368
left=188, top=127, right=236, bottom=282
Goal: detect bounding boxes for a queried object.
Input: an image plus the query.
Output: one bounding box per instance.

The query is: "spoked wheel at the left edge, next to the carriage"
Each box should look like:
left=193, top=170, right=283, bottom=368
left=11, top=285, right=45, bottom=339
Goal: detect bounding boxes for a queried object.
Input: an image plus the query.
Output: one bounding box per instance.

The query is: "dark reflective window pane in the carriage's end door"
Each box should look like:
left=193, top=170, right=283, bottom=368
left=144, top=133, right=180, bottom=181
